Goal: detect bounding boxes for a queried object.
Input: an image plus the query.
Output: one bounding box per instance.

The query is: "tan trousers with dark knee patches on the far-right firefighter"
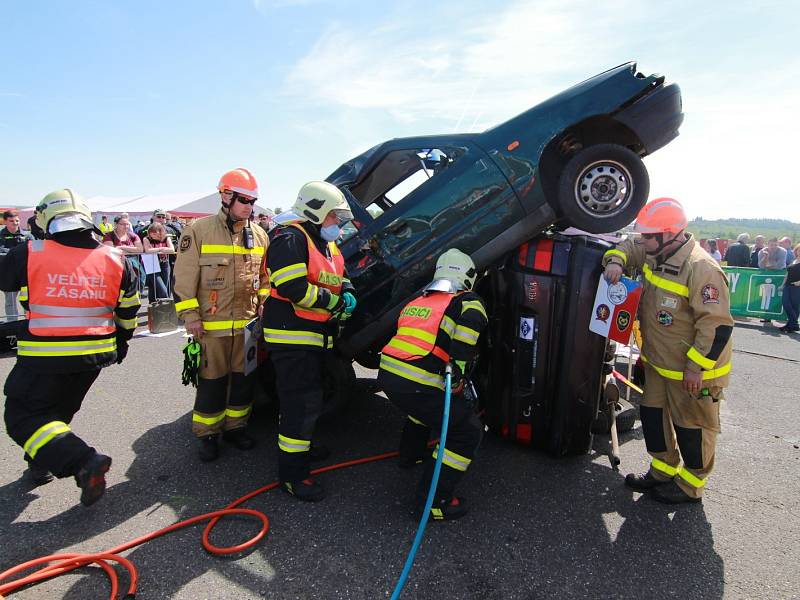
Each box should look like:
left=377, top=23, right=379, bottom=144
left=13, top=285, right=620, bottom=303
left=639, top=365, right=723, bottom=498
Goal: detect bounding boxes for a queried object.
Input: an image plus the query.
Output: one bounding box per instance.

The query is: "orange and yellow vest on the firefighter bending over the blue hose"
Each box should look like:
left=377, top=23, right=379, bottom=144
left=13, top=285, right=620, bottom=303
left=381, top=292, right=459, bottom=362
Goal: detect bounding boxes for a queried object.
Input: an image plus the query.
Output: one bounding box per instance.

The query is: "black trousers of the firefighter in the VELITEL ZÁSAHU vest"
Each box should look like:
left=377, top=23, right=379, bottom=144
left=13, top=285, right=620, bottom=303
left=3, top=364, right=100, bottom=477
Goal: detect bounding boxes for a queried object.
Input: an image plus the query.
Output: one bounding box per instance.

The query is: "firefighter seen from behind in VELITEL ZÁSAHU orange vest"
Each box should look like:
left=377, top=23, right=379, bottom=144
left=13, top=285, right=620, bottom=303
left=0, top=189, right=139, bottom=506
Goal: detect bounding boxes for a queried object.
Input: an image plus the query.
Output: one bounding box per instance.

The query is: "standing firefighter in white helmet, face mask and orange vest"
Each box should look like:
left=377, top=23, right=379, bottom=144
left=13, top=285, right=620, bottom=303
left=263, top=181, right=356, bottom=502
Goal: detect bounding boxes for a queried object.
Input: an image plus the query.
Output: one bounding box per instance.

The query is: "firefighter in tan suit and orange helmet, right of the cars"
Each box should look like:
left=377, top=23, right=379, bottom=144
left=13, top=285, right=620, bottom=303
left=603, top=198, right=733, bottom=504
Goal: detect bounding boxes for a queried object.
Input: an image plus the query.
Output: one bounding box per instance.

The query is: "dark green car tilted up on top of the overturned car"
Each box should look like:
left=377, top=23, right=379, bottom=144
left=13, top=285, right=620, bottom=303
left=327, top=63, right=683, bottom=367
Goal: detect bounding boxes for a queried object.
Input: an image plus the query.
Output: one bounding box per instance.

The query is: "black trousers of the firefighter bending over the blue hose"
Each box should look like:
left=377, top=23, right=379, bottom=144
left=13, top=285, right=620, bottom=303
left=384, top=386, right=483, bottom=502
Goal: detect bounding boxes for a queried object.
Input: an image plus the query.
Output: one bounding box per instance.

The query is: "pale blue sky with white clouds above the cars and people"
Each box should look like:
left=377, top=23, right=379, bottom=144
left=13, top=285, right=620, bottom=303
left=0, top=0, right=800, bottom=222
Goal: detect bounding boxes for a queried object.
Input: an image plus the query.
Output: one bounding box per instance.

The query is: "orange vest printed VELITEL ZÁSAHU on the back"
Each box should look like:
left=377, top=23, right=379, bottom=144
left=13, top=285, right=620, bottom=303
left=27, top=240, right=125, bottom=337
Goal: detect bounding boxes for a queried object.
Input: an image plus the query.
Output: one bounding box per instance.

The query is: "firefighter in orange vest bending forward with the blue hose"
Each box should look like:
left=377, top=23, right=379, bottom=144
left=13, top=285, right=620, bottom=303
left=378, top=248, right=487, bottom=521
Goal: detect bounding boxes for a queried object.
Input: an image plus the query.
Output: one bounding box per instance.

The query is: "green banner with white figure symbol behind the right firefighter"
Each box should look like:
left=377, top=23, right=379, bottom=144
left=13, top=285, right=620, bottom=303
left=722, top=267, right=786, bottom=321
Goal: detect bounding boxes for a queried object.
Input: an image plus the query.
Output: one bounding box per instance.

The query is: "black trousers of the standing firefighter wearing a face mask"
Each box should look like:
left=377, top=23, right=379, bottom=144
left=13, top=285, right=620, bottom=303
left=270, top=350, right=325, bottom=482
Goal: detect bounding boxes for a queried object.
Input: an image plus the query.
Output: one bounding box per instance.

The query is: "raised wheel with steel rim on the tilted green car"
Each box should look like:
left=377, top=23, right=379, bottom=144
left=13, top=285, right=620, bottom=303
left=556, top=144, right=650, bottom=233
